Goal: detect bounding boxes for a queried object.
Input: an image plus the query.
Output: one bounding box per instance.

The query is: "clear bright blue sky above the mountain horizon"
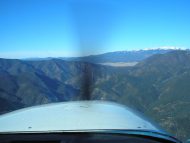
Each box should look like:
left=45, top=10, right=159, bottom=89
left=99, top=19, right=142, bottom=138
left=0, top=0, right=190, bottom=58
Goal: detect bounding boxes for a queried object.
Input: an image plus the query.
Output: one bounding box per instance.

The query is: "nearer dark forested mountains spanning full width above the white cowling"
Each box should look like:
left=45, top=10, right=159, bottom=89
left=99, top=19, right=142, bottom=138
left=0, top=50, right=190, bottom=141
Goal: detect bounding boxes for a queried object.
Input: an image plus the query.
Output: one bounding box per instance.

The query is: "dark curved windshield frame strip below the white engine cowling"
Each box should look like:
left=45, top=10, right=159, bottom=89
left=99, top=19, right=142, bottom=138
left=0, top=129, right=181, bottom=143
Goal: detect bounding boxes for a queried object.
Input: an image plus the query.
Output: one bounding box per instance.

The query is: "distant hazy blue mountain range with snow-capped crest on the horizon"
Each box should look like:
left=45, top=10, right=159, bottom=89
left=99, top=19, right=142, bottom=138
left=24, top=48, right=175, bottom=64
